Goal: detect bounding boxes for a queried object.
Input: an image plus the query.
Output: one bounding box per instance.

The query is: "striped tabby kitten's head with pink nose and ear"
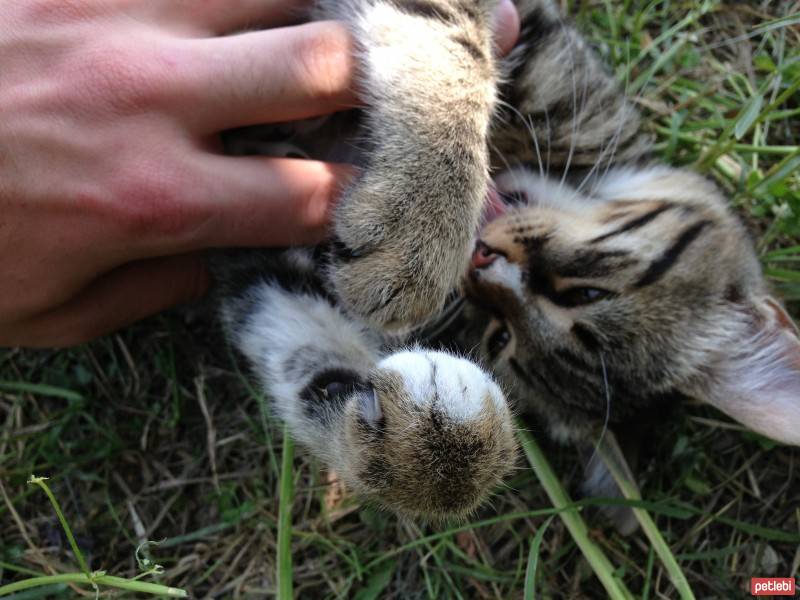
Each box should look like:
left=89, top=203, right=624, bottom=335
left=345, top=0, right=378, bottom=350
left=466, top=167, right=800, bottom=443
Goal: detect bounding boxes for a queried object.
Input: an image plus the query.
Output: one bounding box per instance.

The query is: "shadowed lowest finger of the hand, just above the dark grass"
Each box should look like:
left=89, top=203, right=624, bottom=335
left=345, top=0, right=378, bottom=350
left=8, top=255, right=210, bottom=348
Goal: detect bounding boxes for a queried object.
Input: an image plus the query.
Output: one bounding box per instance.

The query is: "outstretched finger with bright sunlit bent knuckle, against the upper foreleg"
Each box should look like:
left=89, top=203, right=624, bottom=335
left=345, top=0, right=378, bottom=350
left=183, top=21, right=357, bottom=133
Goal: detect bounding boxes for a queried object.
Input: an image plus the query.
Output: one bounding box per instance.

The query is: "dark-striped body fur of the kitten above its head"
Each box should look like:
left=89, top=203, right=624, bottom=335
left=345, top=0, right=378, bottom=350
left=491, top=0, right=649, bottom=178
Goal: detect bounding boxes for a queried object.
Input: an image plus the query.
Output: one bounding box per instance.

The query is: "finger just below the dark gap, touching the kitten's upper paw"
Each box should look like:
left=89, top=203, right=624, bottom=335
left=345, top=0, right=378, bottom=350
left=126, top=153, right=353, bottom=257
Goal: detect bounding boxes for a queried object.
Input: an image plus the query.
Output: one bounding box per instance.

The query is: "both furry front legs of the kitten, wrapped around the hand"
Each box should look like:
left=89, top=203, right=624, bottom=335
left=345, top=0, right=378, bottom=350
left=215, top=0, right=515, bottom=520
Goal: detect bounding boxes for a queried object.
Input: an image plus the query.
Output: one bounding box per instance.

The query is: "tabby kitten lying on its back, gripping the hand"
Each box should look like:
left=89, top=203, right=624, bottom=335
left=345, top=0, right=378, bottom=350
left=216, top=0, right=800, bottom=518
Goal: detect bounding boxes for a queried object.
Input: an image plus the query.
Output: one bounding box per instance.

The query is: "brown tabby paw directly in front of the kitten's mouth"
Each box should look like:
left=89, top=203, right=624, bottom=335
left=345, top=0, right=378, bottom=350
left=328, top=177, right=483, bottom=331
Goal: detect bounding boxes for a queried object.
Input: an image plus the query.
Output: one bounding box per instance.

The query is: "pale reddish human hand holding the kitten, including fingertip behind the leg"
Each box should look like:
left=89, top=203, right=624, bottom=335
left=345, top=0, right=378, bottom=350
left=0, top=0, right=519, bottom=347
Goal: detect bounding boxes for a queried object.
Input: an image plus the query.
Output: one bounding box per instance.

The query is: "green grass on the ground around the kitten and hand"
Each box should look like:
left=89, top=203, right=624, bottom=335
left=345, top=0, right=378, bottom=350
left=0, top=0, right=800, bottom=600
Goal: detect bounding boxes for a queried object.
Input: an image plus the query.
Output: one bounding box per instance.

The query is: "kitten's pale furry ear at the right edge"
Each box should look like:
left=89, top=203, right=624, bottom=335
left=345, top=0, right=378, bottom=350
left=692, top=297, right=800, bottom=445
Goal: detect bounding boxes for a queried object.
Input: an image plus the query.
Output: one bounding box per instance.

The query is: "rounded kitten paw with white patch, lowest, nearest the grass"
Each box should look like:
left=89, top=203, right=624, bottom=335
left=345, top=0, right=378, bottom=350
left=340, top=351, right=516, bottom=520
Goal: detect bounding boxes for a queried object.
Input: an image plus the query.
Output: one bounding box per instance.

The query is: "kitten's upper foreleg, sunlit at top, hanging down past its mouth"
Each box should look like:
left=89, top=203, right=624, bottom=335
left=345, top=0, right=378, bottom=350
left=318, top=0, right=496, bottom=329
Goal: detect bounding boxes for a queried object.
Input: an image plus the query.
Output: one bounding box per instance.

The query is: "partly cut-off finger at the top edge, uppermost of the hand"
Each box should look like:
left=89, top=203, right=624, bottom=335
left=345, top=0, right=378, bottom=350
left=138, top=0, right=312, bottom=34
